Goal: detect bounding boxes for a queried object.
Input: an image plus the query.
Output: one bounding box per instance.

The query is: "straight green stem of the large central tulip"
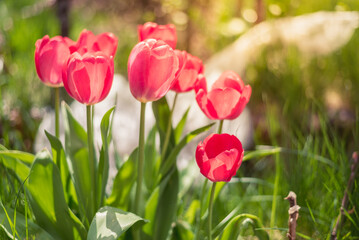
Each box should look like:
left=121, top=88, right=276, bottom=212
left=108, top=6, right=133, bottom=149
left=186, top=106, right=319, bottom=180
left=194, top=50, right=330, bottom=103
left=134, top=103, right=146, bottom=215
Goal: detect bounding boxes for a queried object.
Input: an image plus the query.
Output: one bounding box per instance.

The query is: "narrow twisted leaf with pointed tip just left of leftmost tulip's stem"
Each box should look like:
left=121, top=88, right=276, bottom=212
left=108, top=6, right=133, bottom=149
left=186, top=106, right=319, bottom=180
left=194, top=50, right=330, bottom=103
left=45, top=130, right=78, bottom=206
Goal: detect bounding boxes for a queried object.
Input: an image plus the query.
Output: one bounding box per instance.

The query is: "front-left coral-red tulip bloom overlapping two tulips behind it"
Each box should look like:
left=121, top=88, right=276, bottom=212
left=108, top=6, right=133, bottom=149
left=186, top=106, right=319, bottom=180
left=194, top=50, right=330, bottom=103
left=63, top=52, right=114, bottom=105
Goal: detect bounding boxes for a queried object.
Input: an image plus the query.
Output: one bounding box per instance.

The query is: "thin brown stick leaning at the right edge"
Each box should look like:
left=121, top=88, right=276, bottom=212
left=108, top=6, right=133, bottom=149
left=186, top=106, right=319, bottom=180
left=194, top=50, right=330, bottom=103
left=330, top=152, right=359, bottom=240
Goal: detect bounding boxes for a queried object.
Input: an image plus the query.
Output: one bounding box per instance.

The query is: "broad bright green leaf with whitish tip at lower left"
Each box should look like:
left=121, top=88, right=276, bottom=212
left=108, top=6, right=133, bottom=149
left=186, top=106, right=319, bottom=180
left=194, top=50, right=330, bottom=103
left=26, top=150, right=86, bottom=240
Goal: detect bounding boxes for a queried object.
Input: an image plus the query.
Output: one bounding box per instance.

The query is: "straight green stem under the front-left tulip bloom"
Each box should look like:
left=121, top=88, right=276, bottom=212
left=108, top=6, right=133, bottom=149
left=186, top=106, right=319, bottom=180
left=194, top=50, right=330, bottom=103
left=86, top=105, right=97, bottom=212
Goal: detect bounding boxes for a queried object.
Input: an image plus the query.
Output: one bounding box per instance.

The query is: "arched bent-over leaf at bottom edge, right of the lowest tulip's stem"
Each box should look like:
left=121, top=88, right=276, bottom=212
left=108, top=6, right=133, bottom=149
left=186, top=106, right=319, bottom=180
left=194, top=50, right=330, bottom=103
left=216, top=214, right=269, bottom=240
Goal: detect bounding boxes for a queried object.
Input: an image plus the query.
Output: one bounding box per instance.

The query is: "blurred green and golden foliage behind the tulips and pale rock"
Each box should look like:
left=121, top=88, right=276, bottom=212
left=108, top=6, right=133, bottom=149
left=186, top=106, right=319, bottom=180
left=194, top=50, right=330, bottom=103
left=0, top=0, right=359, bottom=239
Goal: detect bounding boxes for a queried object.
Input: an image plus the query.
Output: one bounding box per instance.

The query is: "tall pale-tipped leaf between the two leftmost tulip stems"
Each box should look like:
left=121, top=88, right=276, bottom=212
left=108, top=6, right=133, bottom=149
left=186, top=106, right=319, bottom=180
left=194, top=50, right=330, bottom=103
left=62, top=103, right=97, bottom=227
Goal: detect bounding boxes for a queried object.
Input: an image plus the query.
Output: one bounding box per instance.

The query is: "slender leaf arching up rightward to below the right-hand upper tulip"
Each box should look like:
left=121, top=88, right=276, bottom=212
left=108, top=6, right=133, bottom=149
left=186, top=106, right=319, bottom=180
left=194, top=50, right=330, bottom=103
left=160, top=123, right=214, bottom=177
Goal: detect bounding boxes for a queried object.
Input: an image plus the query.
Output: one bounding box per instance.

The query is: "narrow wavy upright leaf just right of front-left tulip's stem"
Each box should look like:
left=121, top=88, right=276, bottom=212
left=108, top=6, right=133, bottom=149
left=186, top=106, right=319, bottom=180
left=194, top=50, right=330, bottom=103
left=97, top=107, right=115, bottom=207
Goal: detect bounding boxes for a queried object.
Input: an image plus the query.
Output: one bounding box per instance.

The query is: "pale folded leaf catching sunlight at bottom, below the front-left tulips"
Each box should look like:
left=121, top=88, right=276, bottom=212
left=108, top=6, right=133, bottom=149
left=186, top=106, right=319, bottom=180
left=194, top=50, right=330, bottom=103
left=87, top=207, right=147, bottom=240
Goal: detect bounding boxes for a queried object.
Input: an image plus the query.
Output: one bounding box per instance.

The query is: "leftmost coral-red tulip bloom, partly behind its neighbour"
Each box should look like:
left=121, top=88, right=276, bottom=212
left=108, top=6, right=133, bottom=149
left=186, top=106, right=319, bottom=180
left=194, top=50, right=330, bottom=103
left=35, top=35, right=75, bottom=87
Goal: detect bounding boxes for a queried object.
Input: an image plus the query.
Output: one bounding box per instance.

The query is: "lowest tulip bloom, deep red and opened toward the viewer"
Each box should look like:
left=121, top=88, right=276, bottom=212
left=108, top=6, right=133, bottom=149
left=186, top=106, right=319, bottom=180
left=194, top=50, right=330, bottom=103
left=196, top=134, right=243, bottom=182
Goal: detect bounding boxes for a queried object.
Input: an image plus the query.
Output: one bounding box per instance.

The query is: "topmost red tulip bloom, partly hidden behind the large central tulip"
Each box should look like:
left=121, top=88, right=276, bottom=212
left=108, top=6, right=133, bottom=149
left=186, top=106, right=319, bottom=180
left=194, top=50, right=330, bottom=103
left=138, top=22, right=177, bottom=49
